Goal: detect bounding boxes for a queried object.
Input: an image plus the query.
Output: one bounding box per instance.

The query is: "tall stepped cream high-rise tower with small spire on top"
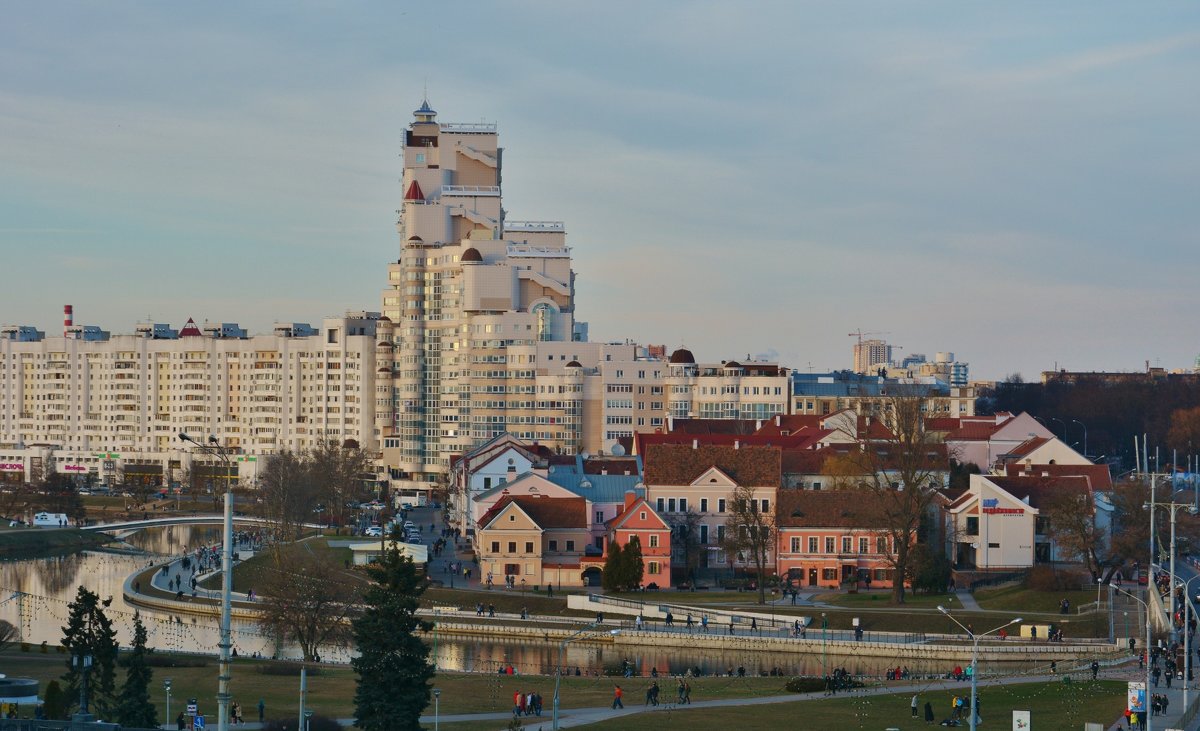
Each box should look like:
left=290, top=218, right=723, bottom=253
left=380, top=102, right=578, bottom=493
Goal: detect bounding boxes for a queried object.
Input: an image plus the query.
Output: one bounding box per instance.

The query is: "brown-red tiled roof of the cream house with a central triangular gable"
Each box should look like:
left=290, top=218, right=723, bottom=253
left=643, top=444, right=782, bottom=487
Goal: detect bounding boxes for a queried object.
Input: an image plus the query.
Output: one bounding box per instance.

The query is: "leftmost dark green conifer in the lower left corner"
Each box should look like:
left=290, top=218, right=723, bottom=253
left=62, top=586, right=118, bottom=718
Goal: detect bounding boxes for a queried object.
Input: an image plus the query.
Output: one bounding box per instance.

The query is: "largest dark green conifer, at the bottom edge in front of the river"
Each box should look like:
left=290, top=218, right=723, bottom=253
left=350, top=543, right=433, bottom=731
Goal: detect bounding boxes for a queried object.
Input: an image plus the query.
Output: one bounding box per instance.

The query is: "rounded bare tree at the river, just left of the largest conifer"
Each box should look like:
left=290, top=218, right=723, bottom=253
left=256, top=544, right=359, bottom=661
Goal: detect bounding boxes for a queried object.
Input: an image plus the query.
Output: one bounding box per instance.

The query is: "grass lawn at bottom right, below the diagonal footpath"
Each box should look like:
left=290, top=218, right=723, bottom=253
left=578, top=681, right=1126, bottom=731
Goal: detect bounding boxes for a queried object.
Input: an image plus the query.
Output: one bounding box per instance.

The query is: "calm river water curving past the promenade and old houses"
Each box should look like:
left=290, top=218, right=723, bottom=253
left=0, top=526, right=1032, bottom=675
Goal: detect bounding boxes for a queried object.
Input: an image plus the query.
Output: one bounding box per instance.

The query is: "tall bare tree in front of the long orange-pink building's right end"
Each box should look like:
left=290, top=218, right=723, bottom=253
left=830, top=387, right=949, bottom=604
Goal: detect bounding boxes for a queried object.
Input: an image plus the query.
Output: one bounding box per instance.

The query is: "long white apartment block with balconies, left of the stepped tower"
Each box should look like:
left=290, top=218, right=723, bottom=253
left=0, top=312, right=381, bottom=485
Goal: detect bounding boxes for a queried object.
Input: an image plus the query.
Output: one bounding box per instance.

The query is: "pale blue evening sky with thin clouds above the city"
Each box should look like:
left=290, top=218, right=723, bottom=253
left=0, top=0, right=1200, bottom=379
